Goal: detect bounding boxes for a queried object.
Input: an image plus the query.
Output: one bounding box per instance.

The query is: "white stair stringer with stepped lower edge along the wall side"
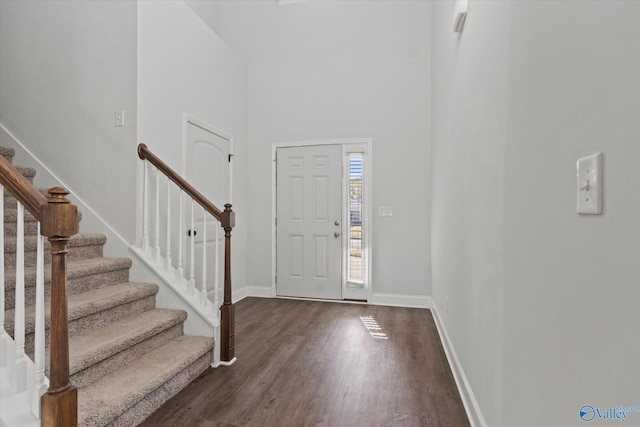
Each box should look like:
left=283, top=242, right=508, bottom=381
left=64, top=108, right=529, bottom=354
left=0, top=123, right=220, bottom=367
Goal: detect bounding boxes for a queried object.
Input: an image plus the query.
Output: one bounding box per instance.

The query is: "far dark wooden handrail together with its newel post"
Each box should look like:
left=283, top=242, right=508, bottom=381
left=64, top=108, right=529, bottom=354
left=138, top=144, right=235, bottom=362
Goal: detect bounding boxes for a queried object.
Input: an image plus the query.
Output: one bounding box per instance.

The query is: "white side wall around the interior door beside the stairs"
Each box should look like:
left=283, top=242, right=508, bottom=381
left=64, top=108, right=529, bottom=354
left=138, top=1, right=248, bottom=298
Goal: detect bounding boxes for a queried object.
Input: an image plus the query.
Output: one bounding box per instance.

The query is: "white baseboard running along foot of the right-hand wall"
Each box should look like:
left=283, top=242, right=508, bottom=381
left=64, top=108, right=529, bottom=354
left=431, top=301, right=487, bottom=427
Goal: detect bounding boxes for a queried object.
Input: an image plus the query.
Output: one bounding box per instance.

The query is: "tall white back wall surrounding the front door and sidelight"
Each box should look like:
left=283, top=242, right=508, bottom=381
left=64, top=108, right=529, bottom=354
left=218, top=1, right=431, bottom=297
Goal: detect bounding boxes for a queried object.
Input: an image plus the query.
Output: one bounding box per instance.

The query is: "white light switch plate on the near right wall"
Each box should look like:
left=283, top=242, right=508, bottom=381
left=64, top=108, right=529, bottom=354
left=578, top=153, right=602, bottom=215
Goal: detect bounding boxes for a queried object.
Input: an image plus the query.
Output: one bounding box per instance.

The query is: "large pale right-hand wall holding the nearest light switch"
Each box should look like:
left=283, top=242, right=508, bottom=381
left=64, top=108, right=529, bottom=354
left=432, top=1, right=640, bottom=427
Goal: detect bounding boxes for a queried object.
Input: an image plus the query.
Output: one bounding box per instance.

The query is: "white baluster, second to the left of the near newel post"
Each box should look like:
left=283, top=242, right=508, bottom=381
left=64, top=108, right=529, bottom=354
left=11, top=202, right=27, bottom=393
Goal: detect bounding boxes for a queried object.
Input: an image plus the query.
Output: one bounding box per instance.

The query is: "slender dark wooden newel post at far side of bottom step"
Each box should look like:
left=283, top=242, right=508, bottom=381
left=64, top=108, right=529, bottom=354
left=220, top=203, right=236, bottom=362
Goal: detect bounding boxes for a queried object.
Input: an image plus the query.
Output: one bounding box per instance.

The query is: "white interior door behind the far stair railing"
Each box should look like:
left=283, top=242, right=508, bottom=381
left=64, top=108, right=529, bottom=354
left=184, top=121, right=231, bottom=300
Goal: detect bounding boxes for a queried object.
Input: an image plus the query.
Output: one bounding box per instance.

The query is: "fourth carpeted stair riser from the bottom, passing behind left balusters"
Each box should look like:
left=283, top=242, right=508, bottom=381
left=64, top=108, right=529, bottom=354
left=4, top=265, right=129, bottom=310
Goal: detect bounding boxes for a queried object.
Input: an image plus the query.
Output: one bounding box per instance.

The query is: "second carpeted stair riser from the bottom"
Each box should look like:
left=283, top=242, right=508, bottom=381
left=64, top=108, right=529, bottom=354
left=71, top=323, right=183, bottom=388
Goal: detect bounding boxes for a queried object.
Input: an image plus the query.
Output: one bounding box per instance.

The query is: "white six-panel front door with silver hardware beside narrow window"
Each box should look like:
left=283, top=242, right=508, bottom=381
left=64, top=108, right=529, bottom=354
left=276, top=145, right=343, bottom=299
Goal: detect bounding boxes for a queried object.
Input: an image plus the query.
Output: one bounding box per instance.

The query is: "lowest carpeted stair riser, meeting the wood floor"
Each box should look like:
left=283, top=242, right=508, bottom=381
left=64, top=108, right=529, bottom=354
left=104, top=353, right=211, bottom=427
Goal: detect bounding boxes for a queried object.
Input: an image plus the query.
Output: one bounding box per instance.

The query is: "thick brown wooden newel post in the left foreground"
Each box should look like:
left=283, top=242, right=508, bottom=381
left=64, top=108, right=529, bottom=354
left=40, top=187, right=78, bottom=427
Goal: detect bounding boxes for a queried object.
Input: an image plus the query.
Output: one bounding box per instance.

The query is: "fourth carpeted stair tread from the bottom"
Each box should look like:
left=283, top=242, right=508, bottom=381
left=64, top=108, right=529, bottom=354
left=4, top=258, right=132, bottom=291
